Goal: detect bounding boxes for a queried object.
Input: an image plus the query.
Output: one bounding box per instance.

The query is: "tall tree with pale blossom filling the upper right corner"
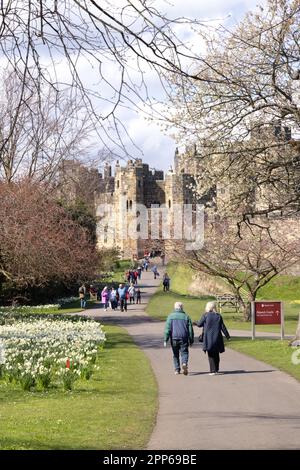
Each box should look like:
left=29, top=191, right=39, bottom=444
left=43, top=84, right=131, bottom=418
left=167, top=0, right=300, bottom=222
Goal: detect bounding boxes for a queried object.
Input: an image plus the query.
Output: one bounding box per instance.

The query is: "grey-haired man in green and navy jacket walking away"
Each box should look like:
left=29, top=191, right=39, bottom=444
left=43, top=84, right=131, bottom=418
left=164, top=302, right=194, bottom=375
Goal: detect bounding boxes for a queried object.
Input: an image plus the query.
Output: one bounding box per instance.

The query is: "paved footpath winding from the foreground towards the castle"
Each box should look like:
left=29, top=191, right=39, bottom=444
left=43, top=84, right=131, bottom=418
left=82, top=264, right=300, bottom=450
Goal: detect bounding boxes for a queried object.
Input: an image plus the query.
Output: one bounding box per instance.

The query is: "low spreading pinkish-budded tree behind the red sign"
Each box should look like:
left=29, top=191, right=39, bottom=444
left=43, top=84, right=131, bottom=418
left=180, top=218, right=300, bottom=320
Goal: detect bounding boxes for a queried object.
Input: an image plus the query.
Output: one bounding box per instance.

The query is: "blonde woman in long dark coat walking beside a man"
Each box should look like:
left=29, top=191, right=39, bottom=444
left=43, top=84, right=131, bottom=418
left=194, top=302, right=230, bottom=375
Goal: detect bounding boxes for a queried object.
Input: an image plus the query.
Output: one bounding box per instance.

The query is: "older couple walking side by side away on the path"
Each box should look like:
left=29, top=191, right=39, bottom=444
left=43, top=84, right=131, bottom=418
left=164, top=302, right=230, bottom=375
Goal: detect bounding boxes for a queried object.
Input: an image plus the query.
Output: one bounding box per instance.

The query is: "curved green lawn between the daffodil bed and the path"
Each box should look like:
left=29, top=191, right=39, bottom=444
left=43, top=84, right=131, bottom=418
left=0, top=326, right=157, bottom=449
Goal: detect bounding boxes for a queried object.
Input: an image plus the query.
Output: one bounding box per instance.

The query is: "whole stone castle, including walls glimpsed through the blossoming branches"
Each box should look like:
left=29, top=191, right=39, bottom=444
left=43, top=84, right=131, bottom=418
left=58, top=121, right=300, bottom=258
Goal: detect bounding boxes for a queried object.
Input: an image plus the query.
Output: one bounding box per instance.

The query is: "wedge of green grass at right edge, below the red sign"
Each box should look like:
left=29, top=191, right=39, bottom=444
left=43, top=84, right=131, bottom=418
left=227, top=338, right=300, bottom=380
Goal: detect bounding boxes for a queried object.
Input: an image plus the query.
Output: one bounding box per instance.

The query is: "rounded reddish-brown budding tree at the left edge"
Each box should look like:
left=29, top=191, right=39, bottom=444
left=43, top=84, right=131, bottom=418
left=0, top=180, right=98, bottom=300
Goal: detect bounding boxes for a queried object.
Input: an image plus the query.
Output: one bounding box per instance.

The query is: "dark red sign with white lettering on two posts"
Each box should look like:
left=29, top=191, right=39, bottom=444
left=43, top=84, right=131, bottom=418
left=251, top=300, right=284, bottom=339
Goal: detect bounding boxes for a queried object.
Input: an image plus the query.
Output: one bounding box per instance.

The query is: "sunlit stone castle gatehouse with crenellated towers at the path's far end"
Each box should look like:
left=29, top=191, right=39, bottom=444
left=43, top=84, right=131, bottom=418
left=95, top=151, right=202, bottom=258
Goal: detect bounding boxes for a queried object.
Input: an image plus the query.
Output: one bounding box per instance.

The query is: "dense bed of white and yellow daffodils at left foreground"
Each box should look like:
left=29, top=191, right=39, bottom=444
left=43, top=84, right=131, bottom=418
left=0, top=316, right=105, bottom=390
